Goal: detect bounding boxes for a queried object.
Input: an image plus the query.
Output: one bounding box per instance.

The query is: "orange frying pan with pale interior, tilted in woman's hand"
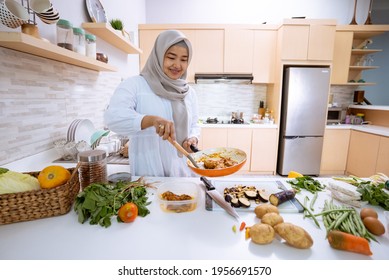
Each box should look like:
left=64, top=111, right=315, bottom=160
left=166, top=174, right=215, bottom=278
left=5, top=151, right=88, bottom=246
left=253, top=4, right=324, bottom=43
left=187, top=147, right=247, bottom=177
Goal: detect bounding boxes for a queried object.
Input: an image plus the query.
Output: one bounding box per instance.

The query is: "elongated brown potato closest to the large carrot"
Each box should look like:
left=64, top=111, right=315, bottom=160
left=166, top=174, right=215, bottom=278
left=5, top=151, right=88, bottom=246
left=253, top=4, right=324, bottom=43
left=274, top=223, right=313, bottom=249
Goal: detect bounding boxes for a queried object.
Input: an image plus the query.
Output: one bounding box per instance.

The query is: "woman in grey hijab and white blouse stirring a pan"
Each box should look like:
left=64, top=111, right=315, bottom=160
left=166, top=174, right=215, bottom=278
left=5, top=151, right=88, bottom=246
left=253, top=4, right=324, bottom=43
left=104, top=30, right=200, bottom=177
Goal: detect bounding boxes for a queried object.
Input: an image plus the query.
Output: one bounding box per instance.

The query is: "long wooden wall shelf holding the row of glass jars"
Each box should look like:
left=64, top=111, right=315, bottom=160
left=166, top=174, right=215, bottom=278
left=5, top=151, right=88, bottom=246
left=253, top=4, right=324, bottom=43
left=0, top=32, right=117, bottom=72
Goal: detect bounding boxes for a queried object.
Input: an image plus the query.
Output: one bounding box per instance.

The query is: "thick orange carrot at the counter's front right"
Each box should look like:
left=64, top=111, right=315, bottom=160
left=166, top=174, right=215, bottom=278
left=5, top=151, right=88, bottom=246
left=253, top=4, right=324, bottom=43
left=327, top=230, right=373, bottom=256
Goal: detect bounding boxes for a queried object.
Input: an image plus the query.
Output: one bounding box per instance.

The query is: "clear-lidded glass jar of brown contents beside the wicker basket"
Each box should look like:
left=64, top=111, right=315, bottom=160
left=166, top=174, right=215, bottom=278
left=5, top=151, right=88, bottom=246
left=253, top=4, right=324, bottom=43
left=78, top=150, right=108, bottom=190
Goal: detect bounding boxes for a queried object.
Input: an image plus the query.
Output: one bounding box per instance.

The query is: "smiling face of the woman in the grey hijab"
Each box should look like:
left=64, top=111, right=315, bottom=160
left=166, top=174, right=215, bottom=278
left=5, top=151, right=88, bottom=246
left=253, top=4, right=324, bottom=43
left=163, top=45, right=189, bottom=80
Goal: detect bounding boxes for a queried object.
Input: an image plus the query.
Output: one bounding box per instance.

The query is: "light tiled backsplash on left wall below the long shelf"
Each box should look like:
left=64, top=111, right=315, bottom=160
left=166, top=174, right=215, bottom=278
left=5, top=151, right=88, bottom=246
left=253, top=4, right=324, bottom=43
left=0, top=48, right=121, bottom=166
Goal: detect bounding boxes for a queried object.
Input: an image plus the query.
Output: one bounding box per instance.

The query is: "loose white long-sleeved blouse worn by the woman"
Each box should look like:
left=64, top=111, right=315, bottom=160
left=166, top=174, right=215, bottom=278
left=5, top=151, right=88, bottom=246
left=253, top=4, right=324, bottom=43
left=104, top=76, right=200, bottom=177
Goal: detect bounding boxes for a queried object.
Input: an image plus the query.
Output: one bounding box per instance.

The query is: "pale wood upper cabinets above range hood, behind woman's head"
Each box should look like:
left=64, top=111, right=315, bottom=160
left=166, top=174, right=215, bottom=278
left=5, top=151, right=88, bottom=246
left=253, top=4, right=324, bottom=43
left=139, top=24, right=279, bottom=83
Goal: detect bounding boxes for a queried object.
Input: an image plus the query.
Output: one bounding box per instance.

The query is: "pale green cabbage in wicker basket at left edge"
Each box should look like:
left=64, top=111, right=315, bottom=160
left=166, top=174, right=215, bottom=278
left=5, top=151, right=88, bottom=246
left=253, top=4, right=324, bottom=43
left=0, top=168, right=40, bottom=194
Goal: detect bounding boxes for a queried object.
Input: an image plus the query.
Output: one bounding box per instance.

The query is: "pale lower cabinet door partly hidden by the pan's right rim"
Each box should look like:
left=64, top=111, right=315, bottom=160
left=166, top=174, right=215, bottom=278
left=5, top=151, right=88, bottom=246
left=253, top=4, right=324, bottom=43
left=227, top=128, right=253, bottom=172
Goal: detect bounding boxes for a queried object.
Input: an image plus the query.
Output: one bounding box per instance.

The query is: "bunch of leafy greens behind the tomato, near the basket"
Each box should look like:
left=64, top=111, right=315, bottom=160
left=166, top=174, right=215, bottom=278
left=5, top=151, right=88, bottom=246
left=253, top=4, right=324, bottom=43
left=74, top=177, right=151, bottom=227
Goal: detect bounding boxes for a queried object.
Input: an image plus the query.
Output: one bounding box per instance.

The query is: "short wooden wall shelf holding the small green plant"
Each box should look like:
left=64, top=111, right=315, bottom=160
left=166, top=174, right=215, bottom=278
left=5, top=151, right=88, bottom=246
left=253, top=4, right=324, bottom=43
left=82, top=22, right=142, bottom=54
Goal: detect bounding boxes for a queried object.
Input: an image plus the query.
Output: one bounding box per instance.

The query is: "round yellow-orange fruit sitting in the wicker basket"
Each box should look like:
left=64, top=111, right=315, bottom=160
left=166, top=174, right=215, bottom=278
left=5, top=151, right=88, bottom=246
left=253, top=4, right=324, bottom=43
left=38, top=165, right=71, bottom=189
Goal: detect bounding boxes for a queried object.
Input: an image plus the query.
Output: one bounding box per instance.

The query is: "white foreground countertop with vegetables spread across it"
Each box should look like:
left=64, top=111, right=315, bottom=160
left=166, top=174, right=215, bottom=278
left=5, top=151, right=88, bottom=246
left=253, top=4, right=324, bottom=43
left=0, top=151, right=389, bottom=260
